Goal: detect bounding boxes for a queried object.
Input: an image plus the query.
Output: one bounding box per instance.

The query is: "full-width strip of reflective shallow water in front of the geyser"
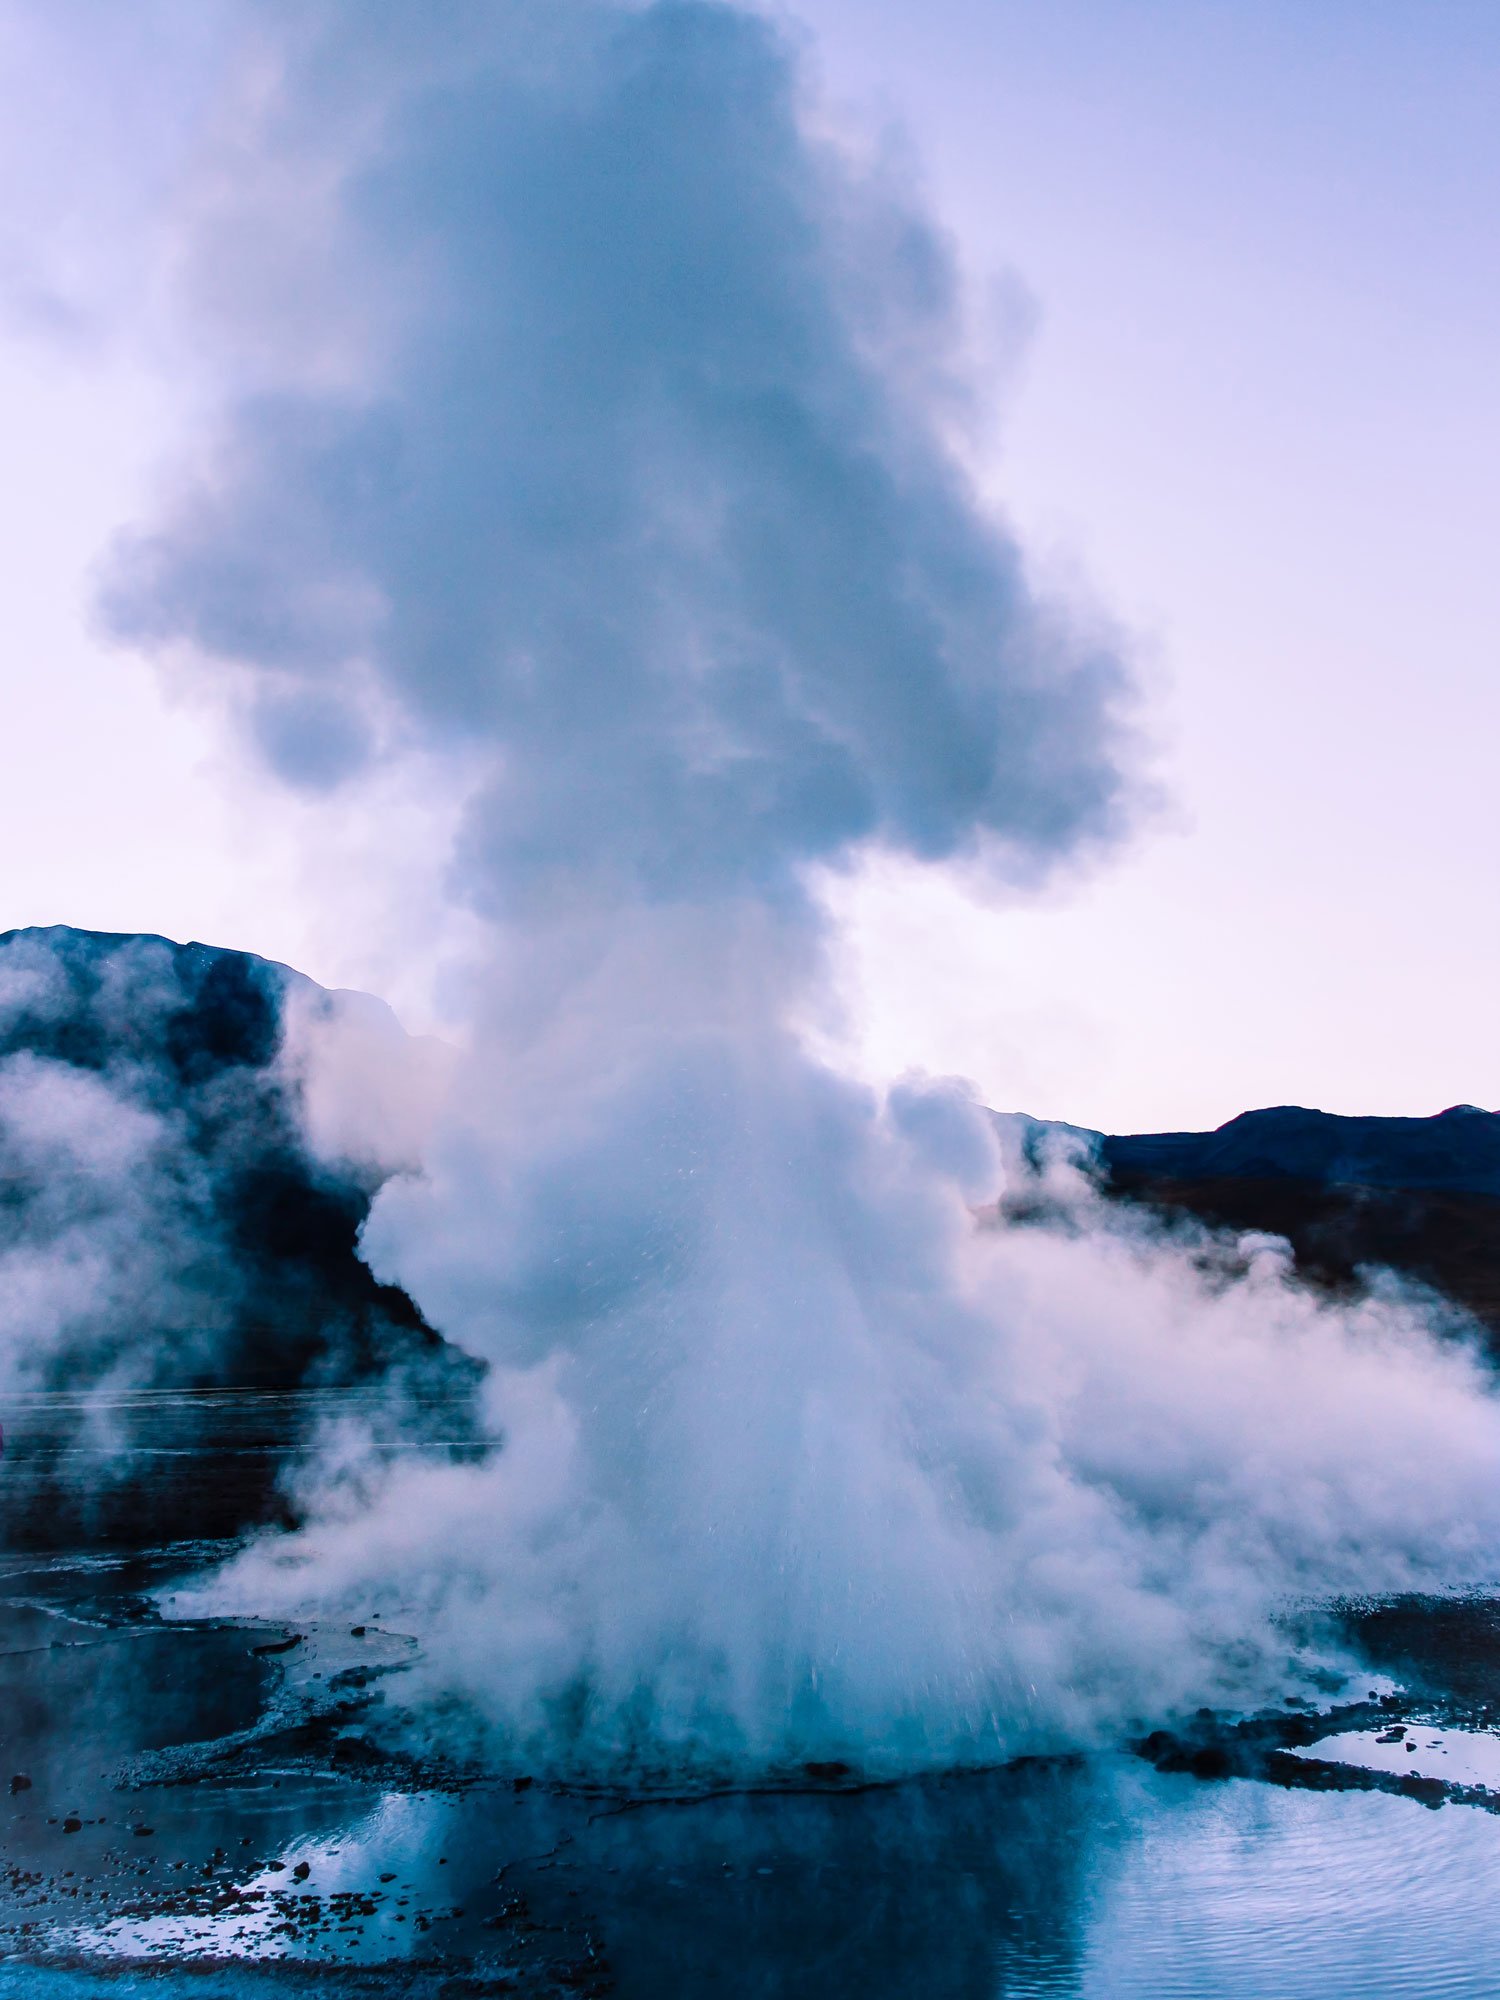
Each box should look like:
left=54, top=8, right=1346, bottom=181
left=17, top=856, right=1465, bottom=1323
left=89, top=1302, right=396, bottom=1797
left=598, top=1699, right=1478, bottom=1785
left=11, top=1762, right=1500, bottom=2000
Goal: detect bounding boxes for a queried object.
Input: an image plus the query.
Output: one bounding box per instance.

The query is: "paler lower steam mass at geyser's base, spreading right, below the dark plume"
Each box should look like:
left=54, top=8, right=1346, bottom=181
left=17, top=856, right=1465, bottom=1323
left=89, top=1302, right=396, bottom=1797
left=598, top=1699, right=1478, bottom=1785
left=185, top=926, right=1500, bottom=1774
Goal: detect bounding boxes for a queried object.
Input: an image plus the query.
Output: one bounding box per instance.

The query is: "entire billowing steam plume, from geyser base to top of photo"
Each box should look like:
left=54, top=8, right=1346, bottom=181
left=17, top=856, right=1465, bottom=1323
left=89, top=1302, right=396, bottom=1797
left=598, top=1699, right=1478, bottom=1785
left=106, top=0, right=1500, bottom=1772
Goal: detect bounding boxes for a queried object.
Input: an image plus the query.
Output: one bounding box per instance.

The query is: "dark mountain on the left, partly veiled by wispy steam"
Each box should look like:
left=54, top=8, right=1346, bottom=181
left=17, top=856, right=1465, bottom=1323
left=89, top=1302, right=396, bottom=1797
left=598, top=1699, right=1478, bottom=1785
left=0, top=926, right=478, bottom=1542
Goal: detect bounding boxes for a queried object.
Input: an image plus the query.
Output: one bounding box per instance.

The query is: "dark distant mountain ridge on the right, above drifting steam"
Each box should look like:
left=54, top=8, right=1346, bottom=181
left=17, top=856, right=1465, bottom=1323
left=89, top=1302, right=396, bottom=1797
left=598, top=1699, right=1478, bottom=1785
left=1032, top=1104, right=1500, bottom=1356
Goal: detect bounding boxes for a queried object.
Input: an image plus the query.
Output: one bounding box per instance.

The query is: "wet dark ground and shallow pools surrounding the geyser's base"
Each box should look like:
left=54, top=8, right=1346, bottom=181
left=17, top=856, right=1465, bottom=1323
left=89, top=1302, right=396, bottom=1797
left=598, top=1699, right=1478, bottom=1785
left=0, top=1410, right=1500, bottom=2000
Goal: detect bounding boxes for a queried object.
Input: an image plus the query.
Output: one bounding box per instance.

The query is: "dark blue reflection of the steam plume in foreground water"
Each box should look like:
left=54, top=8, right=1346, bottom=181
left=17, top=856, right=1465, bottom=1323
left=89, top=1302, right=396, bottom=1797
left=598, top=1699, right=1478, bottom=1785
left=512, top=1770, right=1112, bottom=2000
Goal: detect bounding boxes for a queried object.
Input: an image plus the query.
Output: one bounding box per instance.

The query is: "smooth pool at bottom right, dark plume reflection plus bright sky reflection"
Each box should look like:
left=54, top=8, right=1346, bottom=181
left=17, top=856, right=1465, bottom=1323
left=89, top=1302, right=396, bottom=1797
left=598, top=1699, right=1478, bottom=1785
left=512, top=1766, right=1500, bottom=2000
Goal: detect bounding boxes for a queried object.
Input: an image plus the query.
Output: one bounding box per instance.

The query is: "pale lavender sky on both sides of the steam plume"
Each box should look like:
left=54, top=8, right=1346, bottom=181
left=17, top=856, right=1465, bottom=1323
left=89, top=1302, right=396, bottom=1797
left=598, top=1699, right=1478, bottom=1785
left=0, top=0, right=1500, bottom=1130
